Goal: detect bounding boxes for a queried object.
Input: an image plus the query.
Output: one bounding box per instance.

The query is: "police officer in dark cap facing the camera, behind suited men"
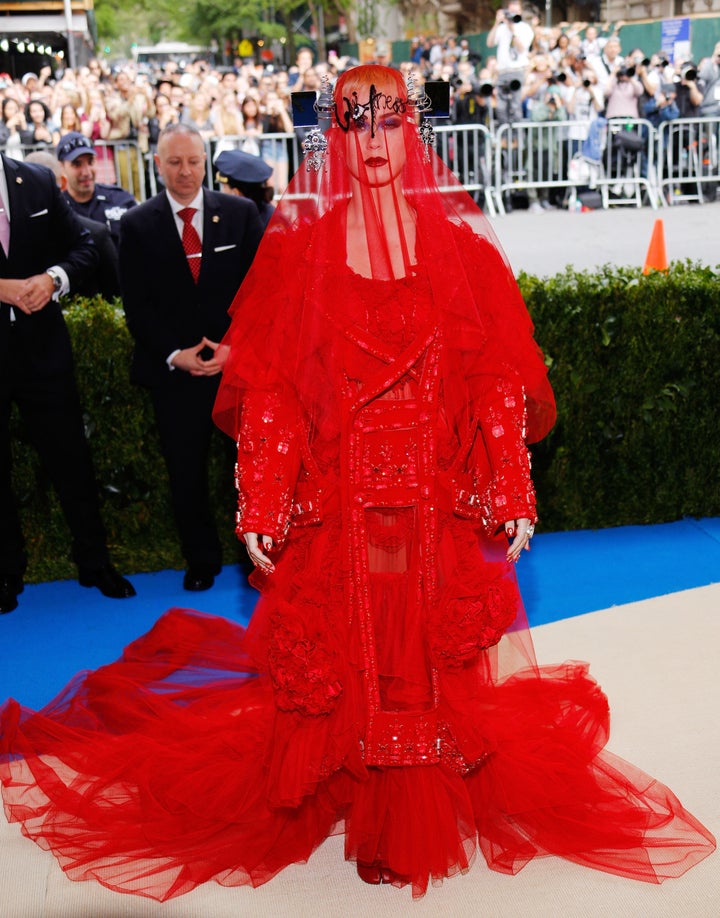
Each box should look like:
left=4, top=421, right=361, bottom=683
left=56, top=131, right=137, bottom=245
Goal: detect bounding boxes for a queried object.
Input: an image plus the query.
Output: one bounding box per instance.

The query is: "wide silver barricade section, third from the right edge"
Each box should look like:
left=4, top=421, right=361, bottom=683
left=494, top=121, right=580, bottom=214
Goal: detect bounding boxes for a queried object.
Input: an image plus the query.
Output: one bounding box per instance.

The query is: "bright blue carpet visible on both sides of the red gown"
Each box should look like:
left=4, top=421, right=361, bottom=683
left=0, top=518, right=720, bottom=708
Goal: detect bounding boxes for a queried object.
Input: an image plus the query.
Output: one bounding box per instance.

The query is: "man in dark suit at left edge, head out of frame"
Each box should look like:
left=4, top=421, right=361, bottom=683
left=0, top=156, right=135, bottom=612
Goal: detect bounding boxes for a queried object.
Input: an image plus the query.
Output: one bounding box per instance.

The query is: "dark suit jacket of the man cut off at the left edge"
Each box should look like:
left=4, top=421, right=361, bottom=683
left=0, top=156, right=97, bottom=376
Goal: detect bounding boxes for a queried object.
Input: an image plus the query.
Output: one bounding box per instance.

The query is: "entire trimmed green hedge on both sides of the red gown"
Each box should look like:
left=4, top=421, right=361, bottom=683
left=12, top=263, right=720, bottom=580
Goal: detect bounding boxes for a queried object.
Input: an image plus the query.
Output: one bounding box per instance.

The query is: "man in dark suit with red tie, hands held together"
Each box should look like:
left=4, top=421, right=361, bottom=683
left=120, top=124, right=262, bottom=590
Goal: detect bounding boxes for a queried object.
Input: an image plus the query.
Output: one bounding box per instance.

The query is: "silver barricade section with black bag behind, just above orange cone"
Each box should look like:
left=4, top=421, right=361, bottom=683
left=597, top=118, right=659, bottom=210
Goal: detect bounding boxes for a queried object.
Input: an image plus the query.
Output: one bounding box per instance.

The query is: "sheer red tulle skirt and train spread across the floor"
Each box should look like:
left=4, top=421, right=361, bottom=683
left=0, top=609, right=714, bottom=899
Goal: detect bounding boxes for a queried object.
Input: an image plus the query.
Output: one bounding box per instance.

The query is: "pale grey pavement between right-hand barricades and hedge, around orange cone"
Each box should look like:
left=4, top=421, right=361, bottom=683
left=492, top=202, right=720, bottom=277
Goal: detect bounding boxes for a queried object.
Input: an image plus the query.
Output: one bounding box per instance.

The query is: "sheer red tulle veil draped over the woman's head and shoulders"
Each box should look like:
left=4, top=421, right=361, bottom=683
left=215, top=67, right=555, bottom=450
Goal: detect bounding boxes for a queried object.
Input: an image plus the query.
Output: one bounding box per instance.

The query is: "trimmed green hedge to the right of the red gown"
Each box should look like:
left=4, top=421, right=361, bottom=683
left=520, top=263, right=720, bottom=529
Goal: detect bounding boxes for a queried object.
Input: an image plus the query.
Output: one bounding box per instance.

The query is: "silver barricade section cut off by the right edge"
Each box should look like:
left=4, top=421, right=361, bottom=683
left=657, top=118, right=720, bottom=206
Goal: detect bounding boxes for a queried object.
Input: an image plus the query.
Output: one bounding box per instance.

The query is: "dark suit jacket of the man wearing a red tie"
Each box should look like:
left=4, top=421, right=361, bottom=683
left=120, top=189, right=262, bottom=386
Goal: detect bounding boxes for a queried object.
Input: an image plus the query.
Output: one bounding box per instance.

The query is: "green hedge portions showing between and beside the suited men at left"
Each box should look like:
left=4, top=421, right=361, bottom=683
left=11, top=298, right=239, bottom=581
